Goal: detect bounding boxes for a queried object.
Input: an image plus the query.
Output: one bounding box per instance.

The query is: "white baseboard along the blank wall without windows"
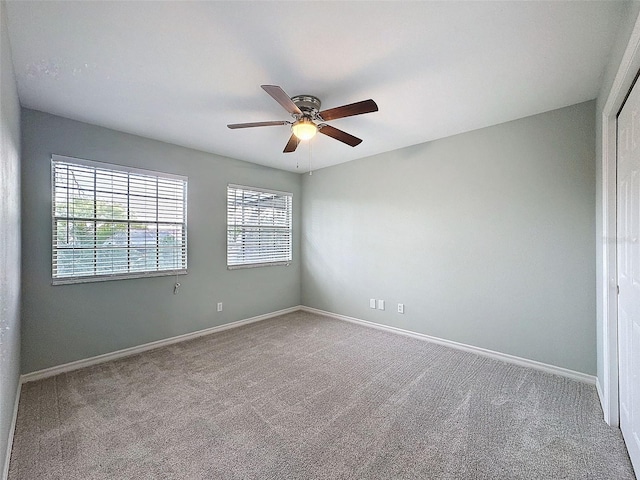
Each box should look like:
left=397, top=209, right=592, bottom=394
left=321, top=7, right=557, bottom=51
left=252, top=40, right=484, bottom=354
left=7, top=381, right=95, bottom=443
left=300, top=306, right=597, bottom=385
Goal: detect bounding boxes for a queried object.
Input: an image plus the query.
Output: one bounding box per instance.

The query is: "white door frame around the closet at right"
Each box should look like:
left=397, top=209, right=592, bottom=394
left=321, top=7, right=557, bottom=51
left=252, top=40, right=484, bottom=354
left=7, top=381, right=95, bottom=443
left=597, top=16, right=640, bottom=427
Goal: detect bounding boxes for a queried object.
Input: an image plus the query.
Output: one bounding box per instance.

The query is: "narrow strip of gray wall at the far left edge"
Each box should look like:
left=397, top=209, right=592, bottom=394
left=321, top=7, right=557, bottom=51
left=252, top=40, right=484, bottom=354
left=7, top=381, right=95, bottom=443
left=0, top=1, right=20, bottom=475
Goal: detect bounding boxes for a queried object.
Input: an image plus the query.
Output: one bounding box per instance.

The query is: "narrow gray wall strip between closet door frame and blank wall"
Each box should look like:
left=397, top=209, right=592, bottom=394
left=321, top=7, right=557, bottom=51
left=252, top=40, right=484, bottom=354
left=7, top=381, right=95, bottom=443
left=596, top=1, right=640, bottom=386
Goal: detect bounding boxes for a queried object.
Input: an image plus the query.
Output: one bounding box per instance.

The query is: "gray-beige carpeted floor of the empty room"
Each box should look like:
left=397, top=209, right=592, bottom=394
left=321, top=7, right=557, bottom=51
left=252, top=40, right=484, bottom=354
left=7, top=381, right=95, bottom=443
left=9, top=312, right=634, bottom=480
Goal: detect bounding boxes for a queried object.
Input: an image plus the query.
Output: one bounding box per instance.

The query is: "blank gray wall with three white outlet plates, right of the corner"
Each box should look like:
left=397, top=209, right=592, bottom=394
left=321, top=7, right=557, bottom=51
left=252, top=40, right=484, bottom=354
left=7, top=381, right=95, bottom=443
left=302, top=101, right=596, bottom=374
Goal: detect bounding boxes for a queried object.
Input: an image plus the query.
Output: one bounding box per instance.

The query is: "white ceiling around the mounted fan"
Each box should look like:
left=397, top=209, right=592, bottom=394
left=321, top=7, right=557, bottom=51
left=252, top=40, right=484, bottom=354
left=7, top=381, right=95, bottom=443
left=7, top=1, right=625, bottom=172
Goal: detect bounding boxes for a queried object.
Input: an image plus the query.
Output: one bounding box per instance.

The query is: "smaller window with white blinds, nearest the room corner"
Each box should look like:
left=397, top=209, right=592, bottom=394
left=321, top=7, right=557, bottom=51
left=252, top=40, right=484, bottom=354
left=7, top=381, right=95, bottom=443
left=227, top=185, right=292, bottom=269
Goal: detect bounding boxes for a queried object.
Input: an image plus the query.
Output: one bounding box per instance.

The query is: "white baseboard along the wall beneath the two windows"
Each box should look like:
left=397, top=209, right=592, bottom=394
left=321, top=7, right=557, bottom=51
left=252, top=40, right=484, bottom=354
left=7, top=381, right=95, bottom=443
left=21, top=306, right=300, bottom=383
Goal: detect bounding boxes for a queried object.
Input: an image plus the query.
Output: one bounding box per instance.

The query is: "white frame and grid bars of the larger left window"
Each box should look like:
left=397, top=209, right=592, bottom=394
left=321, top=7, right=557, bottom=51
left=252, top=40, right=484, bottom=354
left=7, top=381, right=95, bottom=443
left=50, top=154, right=188, bottom=285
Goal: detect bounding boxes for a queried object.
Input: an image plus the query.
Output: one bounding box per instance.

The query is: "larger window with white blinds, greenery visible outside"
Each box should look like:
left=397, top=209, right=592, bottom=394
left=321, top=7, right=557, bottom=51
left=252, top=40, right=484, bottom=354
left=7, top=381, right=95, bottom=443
left=51, top=155, right=187, bottom=284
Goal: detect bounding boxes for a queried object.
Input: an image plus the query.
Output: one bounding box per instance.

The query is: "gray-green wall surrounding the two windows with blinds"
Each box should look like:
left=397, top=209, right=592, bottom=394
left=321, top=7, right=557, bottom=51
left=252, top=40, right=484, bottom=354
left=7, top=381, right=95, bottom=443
left=22, top=109, right=301, bottom=373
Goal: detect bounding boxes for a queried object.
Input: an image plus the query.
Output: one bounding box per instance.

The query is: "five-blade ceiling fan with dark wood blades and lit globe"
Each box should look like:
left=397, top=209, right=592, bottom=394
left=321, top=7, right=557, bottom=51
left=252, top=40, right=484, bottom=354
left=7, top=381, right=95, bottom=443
left=227, top=85, right=378, bottom=153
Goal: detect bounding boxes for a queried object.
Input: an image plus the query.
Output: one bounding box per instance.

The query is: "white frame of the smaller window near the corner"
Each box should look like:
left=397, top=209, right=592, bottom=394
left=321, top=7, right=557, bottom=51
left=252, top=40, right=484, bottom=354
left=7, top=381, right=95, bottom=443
left=225, top=183, right=293, bottom=270
